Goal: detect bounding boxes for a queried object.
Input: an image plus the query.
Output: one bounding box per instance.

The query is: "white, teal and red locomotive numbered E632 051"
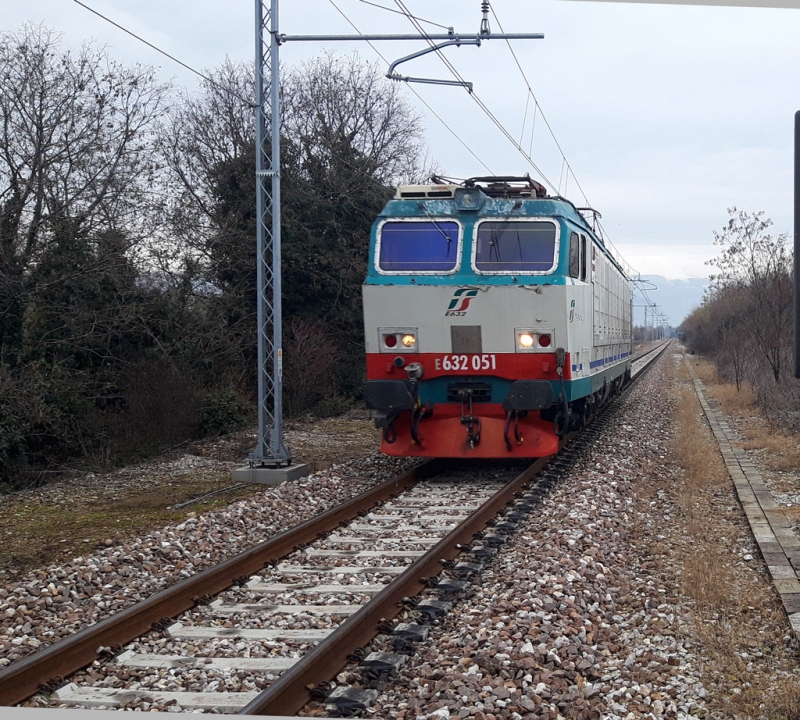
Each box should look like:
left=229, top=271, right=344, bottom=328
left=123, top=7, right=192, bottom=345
left=363, top=176, right=632, bottom=458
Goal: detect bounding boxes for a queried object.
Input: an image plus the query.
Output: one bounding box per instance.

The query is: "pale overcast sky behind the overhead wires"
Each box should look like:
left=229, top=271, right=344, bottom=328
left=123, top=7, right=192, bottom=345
left=0, top=0, right=800, bottom=296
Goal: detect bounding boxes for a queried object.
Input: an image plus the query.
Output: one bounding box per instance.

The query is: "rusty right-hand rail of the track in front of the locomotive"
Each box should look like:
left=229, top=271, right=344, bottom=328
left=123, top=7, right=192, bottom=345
left=239, top=456, right=553, bottom=715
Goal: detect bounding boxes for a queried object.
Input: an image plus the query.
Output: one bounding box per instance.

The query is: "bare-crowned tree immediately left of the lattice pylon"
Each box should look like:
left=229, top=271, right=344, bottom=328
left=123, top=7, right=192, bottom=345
left=158, top=59, right=256, bottom=386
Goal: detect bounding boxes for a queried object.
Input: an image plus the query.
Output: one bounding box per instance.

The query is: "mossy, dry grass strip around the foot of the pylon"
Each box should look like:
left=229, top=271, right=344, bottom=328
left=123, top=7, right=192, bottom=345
left=0, top=418, right=380, bottom=577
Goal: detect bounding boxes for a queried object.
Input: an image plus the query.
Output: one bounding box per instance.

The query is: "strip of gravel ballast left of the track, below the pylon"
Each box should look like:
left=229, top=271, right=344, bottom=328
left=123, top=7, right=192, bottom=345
left=0, top=455, right=409, bottom=667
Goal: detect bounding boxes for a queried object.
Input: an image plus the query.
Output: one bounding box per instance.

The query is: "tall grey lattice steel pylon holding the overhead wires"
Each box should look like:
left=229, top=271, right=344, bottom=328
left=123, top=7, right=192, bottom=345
left=250, top=0, right=292, bottom=467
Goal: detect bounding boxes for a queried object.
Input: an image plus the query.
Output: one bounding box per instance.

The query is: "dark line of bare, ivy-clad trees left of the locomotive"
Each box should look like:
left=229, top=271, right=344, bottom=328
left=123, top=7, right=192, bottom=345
left=0, top=25, right=426, bottom=486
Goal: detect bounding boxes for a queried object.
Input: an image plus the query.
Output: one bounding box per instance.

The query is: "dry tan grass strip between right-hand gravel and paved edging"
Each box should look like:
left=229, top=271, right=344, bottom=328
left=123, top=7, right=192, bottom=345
left=673, top=358, right=800, bottom=720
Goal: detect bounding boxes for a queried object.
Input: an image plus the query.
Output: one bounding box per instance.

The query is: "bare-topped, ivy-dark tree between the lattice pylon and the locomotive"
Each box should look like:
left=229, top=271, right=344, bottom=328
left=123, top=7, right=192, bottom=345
left=282, top=53, right=434, bottom=352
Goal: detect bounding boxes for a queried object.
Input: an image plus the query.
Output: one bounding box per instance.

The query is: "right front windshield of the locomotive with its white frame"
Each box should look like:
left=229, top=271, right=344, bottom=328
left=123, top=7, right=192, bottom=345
left=472, top=217, right=561, bottom=275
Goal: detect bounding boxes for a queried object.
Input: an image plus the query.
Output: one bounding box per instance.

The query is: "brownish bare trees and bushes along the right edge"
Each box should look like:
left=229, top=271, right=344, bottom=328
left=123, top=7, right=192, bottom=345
left=681, top=207, right=800, bottom=430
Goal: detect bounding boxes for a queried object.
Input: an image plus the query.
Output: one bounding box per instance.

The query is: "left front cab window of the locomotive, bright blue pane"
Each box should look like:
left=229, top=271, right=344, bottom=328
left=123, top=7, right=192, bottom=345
left=375, top=220, right=461, bottom=273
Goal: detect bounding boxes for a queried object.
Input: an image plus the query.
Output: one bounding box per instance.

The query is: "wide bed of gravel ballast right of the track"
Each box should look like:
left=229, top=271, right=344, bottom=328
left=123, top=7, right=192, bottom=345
left=340, top=357, right=791, bottom=720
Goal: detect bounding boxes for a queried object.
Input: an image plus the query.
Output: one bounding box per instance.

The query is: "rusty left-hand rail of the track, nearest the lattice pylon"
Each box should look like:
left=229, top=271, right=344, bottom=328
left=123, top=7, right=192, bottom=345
left=0, top=460, right=442, bottom=706
